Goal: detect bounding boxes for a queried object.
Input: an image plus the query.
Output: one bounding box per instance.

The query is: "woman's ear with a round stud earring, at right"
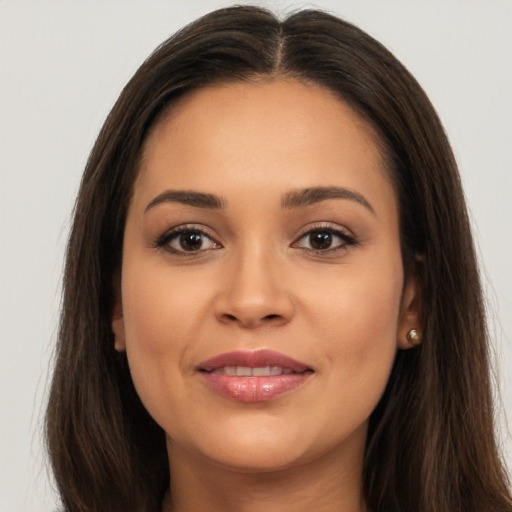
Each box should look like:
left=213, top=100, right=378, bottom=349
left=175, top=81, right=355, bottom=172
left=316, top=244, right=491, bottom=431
left=397, top=258, right=424, bottom=349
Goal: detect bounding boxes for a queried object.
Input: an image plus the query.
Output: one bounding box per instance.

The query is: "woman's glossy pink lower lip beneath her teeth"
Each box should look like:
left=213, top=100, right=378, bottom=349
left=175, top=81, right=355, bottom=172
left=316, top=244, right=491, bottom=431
left=202, top=372, right=312, bottom=402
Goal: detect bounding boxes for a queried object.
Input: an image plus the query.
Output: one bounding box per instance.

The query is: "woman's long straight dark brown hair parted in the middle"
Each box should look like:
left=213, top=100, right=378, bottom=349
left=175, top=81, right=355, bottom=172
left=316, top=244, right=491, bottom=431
left=46, top=6, right=512, bottom=512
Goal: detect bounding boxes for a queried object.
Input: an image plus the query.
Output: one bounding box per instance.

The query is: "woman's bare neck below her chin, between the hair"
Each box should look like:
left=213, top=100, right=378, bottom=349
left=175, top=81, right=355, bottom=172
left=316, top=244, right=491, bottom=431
left=162, top=432, right=366, bottom=512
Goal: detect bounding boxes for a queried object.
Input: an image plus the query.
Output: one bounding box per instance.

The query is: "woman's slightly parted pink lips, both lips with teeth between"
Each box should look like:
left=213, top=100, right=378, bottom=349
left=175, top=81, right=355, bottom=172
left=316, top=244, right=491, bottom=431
left=198, top=350, right=313, bottom=402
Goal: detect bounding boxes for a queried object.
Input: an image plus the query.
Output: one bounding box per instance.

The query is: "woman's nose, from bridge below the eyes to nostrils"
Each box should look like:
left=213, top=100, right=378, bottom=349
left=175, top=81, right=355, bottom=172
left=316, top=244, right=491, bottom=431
left=215, top=250, right=294, bottom=329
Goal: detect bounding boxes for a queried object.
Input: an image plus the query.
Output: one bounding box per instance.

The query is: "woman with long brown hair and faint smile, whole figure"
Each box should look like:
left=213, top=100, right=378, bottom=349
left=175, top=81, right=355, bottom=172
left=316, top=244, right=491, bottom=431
left=47, top=7, right=512, bottom=512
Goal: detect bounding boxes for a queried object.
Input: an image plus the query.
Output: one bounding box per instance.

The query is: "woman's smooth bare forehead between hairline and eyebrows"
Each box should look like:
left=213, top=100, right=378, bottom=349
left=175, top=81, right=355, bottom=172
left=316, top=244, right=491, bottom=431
left=135, top=79, right=393, bottom=212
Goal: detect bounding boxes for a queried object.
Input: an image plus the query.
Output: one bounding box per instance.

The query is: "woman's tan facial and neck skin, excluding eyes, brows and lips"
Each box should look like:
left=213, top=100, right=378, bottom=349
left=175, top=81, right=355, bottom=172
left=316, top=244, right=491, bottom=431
left=112, top=79, right=421, bottom=512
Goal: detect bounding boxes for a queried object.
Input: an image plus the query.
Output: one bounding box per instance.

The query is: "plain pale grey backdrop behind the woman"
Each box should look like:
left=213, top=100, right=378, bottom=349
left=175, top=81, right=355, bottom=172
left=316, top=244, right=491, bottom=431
left=0, top=0, right=512, bottom=512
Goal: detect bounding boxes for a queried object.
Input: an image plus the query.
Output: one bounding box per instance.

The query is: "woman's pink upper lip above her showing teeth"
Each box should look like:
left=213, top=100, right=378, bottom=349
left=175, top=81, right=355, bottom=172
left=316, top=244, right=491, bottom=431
left=198, top=350, right=312, bottom=373
